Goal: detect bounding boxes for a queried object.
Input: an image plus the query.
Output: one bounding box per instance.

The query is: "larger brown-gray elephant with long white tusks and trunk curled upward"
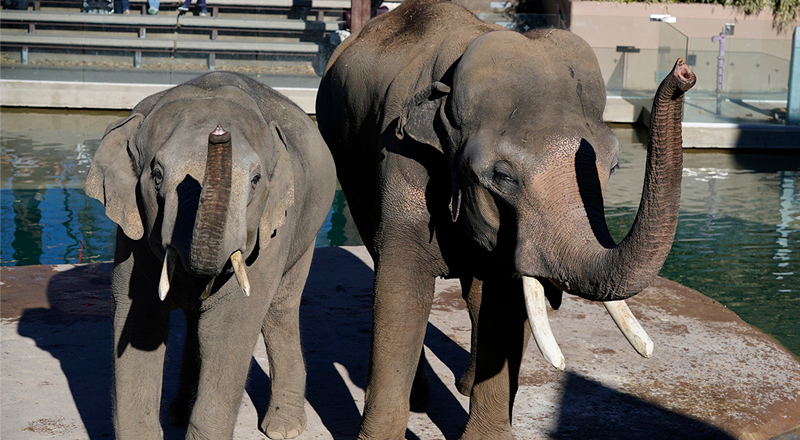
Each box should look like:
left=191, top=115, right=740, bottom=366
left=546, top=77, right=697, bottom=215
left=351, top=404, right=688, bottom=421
left=317, top=0, right=695, bottom=440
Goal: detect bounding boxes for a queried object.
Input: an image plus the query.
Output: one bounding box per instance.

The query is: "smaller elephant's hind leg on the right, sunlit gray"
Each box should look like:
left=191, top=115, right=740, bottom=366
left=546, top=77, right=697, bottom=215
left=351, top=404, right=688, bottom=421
left=261, top=246, right=314, bottom=439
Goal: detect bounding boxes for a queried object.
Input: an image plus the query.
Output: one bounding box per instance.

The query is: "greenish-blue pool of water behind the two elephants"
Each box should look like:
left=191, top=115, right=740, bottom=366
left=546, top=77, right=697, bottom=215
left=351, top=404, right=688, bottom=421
left=0, top=110, right=800, bottom=356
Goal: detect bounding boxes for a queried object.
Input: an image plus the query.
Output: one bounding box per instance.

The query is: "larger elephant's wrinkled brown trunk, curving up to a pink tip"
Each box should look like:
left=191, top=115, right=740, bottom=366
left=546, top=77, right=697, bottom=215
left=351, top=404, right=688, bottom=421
left=565, top=59, right=696, bottom=301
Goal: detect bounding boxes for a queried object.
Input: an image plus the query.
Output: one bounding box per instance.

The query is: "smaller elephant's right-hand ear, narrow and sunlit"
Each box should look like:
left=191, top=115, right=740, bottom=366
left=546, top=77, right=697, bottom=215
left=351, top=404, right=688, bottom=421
left=259, top=121, right=294, bottom=247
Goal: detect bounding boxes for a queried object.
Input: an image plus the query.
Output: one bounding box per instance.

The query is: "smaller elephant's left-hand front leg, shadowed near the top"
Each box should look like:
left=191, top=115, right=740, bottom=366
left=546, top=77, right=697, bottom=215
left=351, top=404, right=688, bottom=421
left=112, top=249, right=169, bottom=440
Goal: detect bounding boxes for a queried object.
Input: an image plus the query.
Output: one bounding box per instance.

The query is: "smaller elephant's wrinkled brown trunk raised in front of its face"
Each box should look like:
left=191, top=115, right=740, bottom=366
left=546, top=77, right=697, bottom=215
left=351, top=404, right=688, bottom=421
left=189, top=125, right=233, bottom=277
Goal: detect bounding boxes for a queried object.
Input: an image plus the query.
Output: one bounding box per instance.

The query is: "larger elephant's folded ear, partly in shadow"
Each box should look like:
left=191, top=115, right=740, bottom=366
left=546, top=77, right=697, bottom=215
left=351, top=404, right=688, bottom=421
left=395, top=81, right=461, bottom=222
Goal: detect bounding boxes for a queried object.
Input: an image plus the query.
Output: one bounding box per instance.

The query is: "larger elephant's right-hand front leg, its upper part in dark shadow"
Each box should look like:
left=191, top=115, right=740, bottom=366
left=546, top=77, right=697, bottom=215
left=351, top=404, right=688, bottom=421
left=461, top=279, right=529, bottom=440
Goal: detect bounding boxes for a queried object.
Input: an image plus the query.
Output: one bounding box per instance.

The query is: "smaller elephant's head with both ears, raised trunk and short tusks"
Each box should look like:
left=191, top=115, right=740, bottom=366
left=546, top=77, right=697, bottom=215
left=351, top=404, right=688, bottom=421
left=86, top=85, right=294, bottom=300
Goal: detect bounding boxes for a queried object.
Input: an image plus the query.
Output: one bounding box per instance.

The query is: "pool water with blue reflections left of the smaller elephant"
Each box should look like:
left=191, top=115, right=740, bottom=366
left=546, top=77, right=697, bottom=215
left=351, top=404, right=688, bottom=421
left=0, top=110, right=119, bottom=265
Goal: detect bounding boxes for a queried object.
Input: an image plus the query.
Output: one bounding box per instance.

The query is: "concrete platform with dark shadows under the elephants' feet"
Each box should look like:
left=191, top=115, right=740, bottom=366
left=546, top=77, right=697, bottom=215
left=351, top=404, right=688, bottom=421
left=0, top=247, right=800, bottom=440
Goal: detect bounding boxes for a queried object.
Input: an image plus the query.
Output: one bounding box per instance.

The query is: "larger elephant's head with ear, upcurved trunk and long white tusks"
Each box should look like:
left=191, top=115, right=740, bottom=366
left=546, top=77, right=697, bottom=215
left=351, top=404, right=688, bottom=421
left=397, top=29, right=695, bottom=368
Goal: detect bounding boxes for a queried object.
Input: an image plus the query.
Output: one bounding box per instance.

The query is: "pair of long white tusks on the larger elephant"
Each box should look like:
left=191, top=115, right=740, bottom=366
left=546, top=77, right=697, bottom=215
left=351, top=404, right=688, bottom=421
left=522, top=276, right=653, bottom=370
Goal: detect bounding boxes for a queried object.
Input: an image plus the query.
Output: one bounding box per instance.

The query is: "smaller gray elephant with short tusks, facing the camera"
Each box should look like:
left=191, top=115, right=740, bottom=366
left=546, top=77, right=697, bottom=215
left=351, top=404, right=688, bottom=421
left=86, top=73, right=336, bottom=439
